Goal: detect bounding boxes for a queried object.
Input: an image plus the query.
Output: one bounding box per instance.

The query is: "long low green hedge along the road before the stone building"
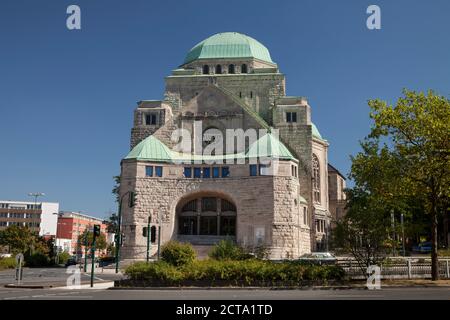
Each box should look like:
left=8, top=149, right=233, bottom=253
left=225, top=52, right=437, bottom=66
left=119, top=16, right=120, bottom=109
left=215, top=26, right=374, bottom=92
left=125, top=259, right=345, bottom=286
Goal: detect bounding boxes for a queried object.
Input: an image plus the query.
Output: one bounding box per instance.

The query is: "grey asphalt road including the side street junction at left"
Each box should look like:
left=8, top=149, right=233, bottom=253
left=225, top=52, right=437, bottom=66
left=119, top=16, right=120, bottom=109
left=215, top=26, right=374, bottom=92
left=0, top=268, right=450, bottom=300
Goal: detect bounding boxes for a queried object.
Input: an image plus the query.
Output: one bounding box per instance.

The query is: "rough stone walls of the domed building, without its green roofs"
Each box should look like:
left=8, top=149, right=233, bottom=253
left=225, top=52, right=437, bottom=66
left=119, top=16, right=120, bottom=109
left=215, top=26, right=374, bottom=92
left=120, top=32, right=342, bottom=259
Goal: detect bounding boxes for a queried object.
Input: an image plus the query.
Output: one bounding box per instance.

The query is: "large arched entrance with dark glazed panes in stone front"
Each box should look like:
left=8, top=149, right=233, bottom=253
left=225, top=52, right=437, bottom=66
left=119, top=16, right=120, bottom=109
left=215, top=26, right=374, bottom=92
left=177, top=196, right=236, bottom=242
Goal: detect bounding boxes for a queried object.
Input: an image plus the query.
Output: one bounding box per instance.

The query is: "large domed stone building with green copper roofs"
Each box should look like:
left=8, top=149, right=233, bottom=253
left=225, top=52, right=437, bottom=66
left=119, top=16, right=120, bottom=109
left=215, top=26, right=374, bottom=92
left=120, top=32, right=348, bottom=260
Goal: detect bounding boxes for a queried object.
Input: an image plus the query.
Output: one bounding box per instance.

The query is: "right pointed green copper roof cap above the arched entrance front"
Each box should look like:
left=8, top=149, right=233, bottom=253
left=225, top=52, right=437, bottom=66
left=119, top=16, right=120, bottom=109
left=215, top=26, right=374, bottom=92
left=245, top=133, right=295, bottom=160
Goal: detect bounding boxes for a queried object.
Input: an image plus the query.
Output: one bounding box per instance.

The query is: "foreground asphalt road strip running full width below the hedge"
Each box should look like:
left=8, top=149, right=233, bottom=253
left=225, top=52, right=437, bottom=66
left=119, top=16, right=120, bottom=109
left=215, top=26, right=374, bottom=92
left=0, top=287, right=450, bottom=300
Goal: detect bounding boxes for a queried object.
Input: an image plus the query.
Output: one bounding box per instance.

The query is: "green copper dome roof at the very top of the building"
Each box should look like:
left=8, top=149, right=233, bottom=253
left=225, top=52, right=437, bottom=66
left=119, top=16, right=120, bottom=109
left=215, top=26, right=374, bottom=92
left=184, top=32, right=273, bottom=64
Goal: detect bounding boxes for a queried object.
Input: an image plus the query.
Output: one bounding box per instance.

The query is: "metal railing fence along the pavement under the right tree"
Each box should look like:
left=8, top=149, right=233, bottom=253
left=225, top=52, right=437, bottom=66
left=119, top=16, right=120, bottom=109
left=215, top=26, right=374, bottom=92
left=338, top=258, right=450, bottom=279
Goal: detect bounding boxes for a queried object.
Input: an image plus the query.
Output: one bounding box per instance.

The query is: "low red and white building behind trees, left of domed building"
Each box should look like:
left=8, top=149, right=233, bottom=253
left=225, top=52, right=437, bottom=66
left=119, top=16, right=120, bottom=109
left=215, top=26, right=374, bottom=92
left=56, top=211, right=110, bottom=255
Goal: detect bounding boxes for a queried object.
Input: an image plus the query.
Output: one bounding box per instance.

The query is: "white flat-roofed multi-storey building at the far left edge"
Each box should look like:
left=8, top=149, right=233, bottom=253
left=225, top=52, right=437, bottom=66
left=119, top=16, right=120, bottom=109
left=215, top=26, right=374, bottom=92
left=0, top=200, right=59, bottom=236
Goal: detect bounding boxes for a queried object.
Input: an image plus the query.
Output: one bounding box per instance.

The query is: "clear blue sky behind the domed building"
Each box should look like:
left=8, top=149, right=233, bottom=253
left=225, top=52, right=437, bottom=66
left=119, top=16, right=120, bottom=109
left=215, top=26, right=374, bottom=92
left=0, top=0, right=450, bottom=217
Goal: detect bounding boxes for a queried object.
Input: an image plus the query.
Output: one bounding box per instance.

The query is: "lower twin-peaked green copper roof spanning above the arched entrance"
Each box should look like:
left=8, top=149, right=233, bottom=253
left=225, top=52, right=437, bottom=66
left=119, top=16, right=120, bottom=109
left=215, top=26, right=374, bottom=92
left=125, top=133, right=296, bottom=162
